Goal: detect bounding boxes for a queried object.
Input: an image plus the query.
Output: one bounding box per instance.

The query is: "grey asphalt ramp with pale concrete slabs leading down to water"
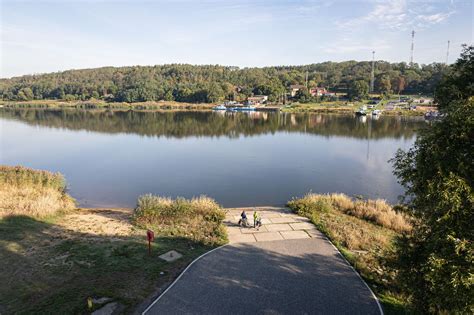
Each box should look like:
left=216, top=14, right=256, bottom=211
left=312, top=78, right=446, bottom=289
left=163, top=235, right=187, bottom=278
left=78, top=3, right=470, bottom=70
left=147, top=209, right=380, bottom=314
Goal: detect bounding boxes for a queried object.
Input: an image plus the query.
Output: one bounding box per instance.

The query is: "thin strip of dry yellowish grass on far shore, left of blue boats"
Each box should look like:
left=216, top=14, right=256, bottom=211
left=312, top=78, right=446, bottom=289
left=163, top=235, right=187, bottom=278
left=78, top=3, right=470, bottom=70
left=0, top=100, right=215, bottom=110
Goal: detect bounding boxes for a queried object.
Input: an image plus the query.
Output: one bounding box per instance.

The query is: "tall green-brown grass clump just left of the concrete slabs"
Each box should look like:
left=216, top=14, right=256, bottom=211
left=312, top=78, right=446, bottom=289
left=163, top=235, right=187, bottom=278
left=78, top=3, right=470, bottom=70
left=133, top=194, right=227, bottom=245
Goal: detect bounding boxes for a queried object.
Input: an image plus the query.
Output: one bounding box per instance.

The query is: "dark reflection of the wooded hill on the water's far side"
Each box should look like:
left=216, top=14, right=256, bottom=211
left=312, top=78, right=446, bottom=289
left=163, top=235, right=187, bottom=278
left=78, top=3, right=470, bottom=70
left=0, top=109, right=422, bottom=139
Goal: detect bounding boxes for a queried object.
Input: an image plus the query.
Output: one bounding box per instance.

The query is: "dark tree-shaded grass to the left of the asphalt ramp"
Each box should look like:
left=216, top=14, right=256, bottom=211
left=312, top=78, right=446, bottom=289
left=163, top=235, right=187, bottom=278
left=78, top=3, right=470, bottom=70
left=0, top=216, right=214, bottom=314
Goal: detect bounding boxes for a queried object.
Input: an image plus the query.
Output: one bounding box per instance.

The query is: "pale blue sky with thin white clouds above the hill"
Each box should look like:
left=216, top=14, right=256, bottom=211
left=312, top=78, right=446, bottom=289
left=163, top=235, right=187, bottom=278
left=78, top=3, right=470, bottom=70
left=0, top=0, right=474, bottom=78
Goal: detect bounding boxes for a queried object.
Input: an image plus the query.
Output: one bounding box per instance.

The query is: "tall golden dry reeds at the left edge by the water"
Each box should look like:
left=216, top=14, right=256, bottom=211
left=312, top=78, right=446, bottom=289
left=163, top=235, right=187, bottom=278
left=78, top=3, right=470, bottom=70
left=0, top=165, right=75, bottom=217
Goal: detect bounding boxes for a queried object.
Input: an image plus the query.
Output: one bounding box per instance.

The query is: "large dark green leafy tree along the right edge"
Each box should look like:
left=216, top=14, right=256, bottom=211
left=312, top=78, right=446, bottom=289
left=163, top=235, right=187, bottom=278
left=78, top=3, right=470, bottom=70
left=393, top=47, right=474, bottom=313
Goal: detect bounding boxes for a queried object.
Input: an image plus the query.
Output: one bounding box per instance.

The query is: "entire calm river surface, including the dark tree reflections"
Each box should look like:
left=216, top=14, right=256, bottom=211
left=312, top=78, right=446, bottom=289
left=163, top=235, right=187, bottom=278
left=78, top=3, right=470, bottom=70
left=0, top=109, right=424, bottom=206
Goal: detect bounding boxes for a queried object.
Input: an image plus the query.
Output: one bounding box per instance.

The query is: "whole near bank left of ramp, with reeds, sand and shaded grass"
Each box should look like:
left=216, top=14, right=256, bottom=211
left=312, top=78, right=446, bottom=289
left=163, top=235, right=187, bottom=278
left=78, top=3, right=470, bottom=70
left=0, top=166, right=226, bottom=314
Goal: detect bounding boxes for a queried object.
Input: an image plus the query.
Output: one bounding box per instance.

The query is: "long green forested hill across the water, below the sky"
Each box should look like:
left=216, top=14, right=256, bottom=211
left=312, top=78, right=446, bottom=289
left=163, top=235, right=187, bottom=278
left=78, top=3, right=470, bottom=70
left=0, top=61, right=446, bottom=102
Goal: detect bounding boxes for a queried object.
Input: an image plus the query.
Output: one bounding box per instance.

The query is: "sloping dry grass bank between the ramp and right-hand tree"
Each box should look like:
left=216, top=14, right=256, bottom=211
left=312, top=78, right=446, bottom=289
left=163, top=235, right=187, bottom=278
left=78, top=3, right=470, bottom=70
left=288, top=194, right=411, bottom=314
